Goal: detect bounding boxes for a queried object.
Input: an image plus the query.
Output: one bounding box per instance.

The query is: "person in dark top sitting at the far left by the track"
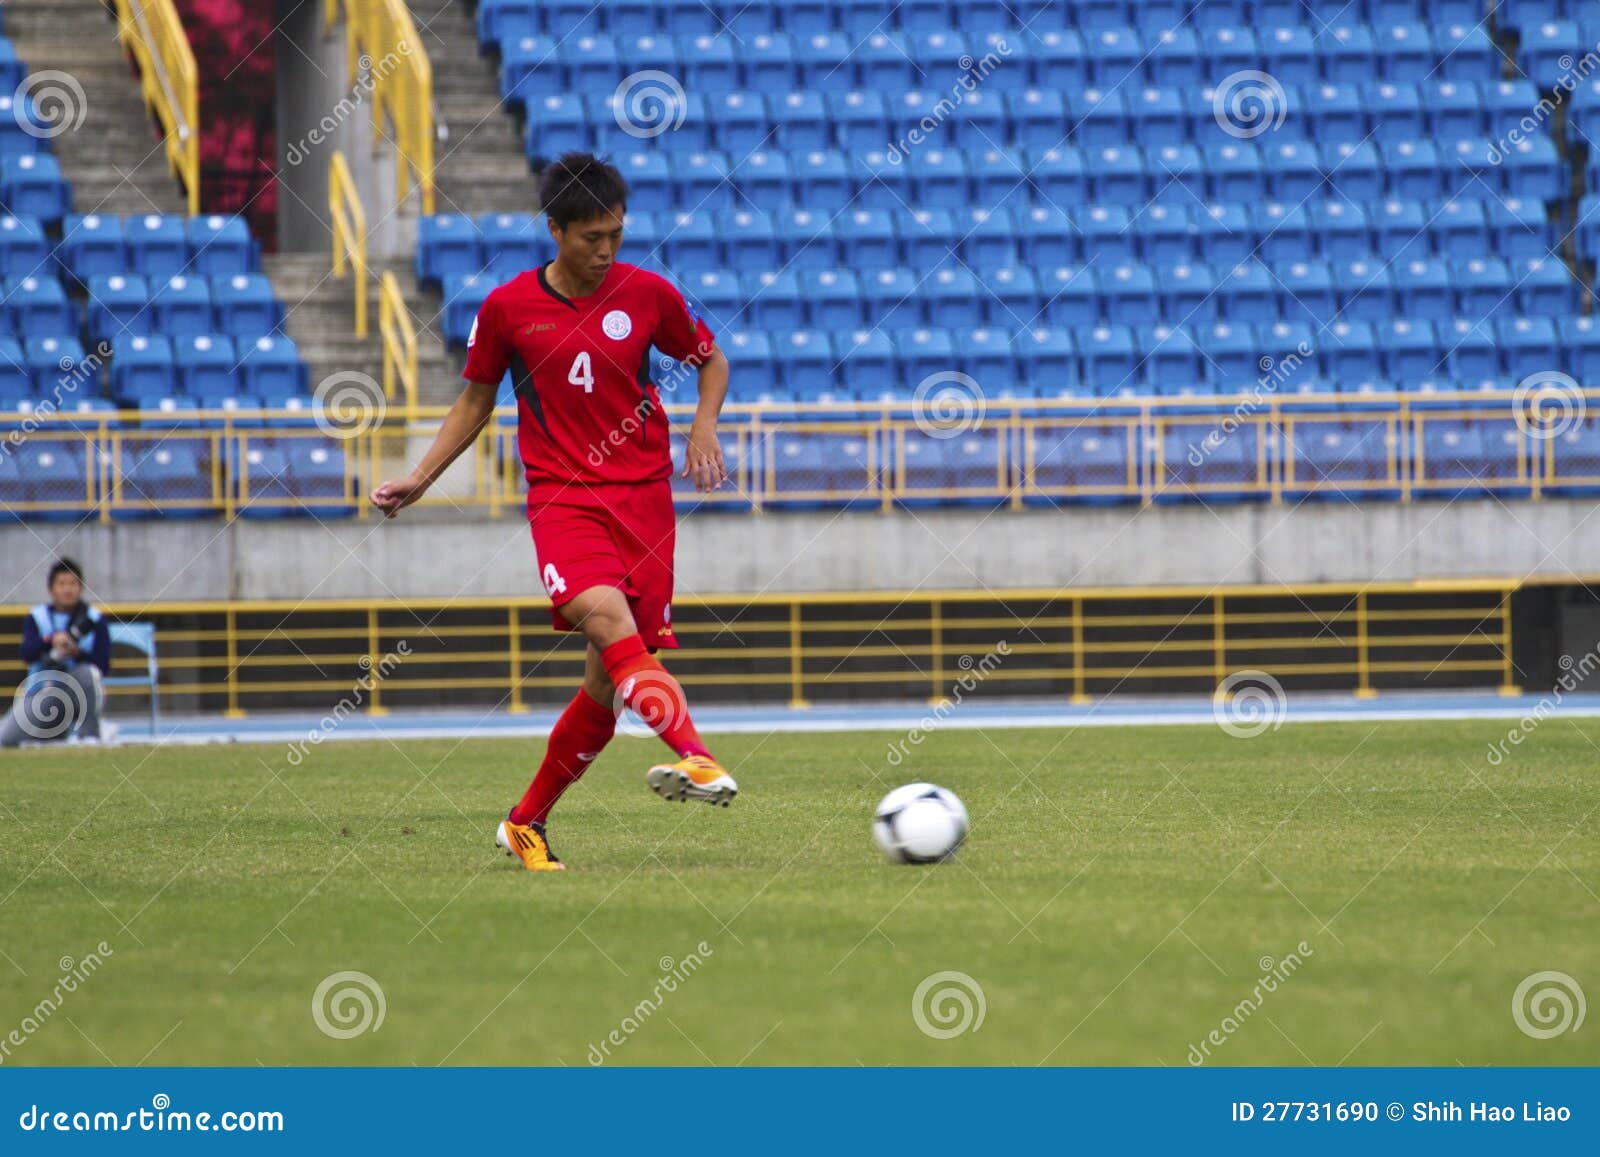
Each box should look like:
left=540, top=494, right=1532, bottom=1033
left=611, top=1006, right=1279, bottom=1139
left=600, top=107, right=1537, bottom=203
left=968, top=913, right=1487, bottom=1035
left=0, top=558, right=110, bottom=747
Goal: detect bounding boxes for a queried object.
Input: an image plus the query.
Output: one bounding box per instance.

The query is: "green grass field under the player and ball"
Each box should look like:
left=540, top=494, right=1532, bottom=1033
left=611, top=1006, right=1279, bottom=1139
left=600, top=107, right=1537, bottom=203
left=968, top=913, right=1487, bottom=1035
left=0, top=720, right=1600, bottom=1066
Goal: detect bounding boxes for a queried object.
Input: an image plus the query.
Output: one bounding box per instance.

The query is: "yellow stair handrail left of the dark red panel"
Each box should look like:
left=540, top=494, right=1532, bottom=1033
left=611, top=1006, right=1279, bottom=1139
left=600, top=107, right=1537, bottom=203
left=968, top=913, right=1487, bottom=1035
left=114, top=0, right=200, bottom=216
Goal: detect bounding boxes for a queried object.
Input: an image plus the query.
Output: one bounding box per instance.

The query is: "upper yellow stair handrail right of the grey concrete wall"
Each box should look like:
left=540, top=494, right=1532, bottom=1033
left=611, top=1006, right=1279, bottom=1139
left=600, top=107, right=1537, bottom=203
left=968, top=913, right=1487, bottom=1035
left=323, top=0, right=435, bottom=213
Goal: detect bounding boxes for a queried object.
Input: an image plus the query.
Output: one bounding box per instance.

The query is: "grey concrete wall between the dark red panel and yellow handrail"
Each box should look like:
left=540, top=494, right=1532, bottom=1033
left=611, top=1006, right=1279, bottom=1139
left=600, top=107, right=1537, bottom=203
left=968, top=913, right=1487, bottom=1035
left=277, top=0, right=406, bottom=261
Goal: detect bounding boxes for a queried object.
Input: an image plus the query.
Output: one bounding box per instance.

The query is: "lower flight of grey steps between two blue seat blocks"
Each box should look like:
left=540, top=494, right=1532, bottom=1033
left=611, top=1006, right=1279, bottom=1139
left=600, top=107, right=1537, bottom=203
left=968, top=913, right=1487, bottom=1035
left=261, top=253, right=462, bottom=410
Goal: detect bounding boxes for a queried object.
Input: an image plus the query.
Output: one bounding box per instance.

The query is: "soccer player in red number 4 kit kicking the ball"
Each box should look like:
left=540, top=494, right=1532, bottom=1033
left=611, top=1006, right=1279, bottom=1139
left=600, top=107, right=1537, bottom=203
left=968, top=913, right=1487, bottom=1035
left=371, top=154, right=739, bottom=871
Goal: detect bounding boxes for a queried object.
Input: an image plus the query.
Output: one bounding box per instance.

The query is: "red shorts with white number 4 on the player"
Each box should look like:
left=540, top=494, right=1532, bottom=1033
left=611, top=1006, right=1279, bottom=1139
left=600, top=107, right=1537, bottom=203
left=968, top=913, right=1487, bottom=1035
left=528, top=478, right=678, bottom=651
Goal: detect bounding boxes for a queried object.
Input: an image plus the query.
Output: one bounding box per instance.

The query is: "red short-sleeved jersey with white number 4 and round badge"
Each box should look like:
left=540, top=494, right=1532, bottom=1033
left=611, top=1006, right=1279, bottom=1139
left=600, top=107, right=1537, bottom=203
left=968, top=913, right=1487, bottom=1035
left=461, top=261, right=714, bottom=483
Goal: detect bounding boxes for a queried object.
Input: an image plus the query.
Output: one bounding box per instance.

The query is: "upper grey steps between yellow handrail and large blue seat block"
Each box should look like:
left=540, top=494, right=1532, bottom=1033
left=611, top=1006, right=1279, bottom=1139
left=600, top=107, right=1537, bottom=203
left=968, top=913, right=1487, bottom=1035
left=410, top=0, right=536, bottom=216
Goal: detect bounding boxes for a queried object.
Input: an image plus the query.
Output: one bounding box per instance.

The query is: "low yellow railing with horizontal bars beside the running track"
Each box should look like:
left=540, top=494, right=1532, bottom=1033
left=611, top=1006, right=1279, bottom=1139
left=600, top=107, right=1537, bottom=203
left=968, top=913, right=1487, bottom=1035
left=0, top=579, right=1520, bottom=714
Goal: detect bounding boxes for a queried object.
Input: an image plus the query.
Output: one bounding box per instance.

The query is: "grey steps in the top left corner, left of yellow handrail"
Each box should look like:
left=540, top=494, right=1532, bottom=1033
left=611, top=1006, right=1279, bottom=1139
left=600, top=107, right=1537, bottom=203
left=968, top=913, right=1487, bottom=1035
left=5, top=0, right=187, bottom=214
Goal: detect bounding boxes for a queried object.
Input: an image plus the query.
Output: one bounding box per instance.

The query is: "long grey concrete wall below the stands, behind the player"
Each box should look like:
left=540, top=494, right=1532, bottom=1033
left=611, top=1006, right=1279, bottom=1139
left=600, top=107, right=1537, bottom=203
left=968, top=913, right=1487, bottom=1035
left=0, top=501, right=1600, bottom=603
